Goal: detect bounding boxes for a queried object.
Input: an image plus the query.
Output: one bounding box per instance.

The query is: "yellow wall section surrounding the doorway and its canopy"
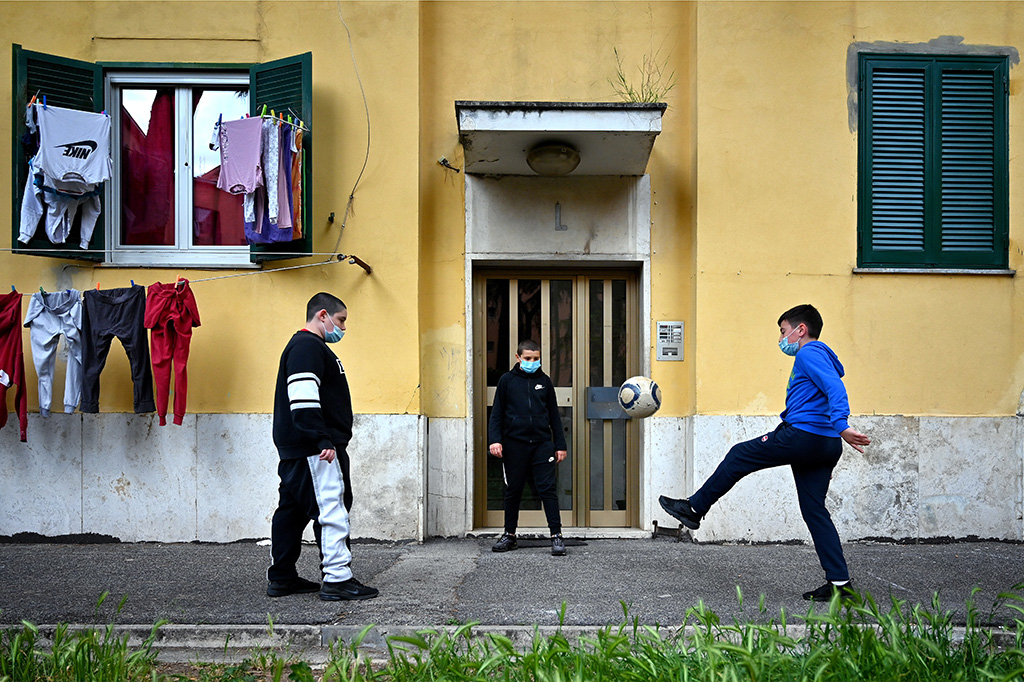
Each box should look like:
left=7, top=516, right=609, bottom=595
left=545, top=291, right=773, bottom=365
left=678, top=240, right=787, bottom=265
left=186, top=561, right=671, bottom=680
left=420, top=2, right=695, bottom=417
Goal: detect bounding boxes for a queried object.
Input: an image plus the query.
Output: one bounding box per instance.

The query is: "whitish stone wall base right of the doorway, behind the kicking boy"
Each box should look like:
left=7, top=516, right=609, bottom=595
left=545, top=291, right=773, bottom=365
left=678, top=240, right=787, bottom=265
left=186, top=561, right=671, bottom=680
left=651, top=416, right=1024, bottom=542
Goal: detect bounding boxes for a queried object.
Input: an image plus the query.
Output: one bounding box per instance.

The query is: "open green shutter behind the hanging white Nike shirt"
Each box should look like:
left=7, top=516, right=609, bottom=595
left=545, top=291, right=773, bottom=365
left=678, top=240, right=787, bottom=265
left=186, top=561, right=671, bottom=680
left=11, top=45, right=105, bottom=260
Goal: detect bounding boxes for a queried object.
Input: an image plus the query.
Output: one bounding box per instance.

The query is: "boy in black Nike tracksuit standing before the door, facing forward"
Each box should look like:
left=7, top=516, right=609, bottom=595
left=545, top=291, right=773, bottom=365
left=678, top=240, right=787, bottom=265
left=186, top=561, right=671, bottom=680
left=487, top=339, right=567, bottom=556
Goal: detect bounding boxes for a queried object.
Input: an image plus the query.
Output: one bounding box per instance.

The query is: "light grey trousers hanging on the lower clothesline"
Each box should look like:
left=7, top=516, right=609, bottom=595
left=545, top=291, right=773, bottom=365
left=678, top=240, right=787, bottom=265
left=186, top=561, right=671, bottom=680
left=25, top=289, right=82, bottom=417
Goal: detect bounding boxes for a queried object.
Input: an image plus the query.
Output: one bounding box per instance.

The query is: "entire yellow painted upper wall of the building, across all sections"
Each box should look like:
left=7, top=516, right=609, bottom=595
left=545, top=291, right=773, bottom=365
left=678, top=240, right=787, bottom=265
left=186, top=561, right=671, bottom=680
left=6, top=1, right=1024, bottom=425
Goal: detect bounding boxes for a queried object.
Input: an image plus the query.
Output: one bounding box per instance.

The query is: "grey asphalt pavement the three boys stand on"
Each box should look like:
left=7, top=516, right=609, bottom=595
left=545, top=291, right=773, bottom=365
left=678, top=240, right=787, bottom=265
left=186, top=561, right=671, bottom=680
left=0, top=536, right=1024, bottom=659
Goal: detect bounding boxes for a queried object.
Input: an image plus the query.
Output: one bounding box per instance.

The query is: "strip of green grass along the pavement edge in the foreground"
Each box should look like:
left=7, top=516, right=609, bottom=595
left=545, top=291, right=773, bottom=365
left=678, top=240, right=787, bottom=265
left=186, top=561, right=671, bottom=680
left=0, top=583, right=1024, bottom=682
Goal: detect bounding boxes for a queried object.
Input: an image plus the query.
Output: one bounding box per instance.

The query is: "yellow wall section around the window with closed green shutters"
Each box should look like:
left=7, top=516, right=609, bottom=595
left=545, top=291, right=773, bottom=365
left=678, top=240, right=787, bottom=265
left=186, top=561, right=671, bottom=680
left=695, top=2, right=1024, bottom=415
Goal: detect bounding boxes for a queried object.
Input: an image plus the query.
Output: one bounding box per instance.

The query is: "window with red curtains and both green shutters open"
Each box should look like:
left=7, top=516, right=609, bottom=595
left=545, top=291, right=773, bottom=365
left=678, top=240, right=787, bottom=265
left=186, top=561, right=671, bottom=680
left=12, top=45, right=312, bottom=267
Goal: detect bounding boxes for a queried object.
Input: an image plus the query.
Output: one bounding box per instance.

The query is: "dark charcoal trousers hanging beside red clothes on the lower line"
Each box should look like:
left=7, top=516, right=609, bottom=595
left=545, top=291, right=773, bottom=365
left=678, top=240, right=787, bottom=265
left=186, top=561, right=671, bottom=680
left=79, top=285, right=157, bottom=415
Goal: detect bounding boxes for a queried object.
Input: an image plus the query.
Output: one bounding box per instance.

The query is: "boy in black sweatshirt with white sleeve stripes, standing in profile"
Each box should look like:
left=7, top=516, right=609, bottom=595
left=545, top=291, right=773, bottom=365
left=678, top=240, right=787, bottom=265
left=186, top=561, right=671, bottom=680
left=266, top=293, right=378, bottom=601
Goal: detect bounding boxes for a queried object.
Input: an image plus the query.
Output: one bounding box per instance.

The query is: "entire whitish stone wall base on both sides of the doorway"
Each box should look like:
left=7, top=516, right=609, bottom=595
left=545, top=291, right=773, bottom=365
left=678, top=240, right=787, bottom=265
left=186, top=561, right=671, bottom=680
left=0, top=414, right=1024, bottom=543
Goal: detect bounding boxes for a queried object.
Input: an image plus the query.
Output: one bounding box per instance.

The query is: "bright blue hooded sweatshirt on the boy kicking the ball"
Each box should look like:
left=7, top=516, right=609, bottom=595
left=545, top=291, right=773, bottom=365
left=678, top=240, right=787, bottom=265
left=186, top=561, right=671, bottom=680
left=780, top=341, right=850, bottom=436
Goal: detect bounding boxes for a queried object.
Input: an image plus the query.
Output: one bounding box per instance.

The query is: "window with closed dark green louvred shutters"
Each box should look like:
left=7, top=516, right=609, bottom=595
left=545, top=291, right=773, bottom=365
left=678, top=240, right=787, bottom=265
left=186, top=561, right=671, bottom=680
left=857, top=53, right=1009, bottom=268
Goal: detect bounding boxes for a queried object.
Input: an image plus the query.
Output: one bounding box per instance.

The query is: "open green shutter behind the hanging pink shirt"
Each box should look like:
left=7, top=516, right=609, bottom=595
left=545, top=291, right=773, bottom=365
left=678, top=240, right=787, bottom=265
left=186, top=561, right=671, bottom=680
left=249, top=52, right=313, bottom=262
